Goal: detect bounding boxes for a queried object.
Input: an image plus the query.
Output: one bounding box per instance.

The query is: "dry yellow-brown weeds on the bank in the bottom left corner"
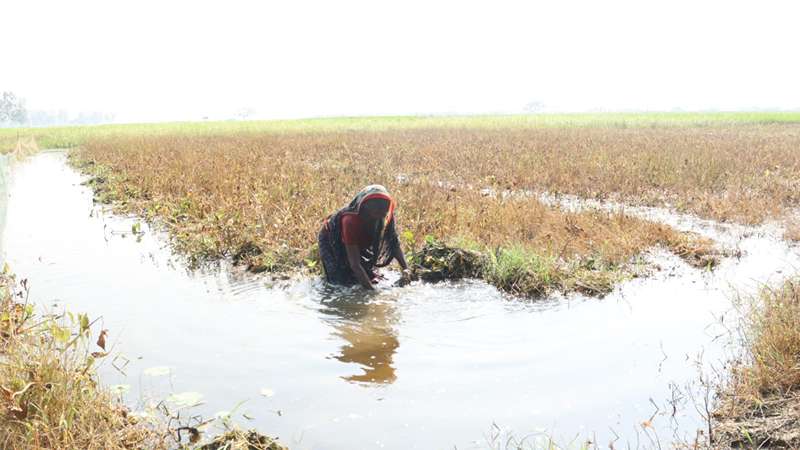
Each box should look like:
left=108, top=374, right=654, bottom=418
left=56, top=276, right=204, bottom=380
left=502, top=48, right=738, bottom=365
left=0, top=274, right=167, bottom=449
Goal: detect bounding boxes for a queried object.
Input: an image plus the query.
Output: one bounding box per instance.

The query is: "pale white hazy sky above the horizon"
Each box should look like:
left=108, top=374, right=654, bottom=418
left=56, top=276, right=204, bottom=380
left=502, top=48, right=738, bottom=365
left=0, top=0, right=800, bottom=121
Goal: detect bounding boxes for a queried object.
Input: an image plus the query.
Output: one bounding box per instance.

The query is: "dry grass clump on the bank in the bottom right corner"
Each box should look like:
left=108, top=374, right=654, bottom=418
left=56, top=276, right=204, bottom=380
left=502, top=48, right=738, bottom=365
left=716, top=278, right=800, bottom=448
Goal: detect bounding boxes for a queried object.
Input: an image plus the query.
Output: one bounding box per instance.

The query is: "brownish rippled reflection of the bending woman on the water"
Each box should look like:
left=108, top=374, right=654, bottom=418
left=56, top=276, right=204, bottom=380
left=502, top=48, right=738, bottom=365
left=320, top=288, right=400, bottom=384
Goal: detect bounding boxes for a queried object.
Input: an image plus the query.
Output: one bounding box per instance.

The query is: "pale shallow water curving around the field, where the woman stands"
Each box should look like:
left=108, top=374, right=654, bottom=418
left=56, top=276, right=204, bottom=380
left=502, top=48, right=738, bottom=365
left=2, top=153, right=800, bottom=449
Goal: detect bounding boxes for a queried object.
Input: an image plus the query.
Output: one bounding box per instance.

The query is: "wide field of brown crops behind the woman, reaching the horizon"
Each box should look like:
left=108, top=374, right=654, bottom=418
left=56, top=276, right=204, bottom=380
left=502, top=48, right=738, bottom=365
left=59, top=115, right=800, bottom=294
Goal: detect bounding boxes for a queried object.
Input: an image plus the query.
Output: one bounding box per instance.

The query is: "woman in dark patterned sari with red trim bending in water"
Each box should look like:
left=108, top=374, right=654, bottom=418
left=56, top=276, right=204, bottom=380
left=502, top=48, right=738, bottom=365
left=319, top=184, right=408, bottom=289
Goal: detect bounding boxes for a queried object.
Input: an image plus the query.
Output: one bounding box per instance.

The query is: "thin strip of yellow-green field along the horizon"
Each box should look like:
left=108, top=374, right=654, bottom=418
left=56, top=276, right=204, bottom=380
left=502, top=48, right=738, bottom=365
left=0, top=112, right=800, bottom=153
